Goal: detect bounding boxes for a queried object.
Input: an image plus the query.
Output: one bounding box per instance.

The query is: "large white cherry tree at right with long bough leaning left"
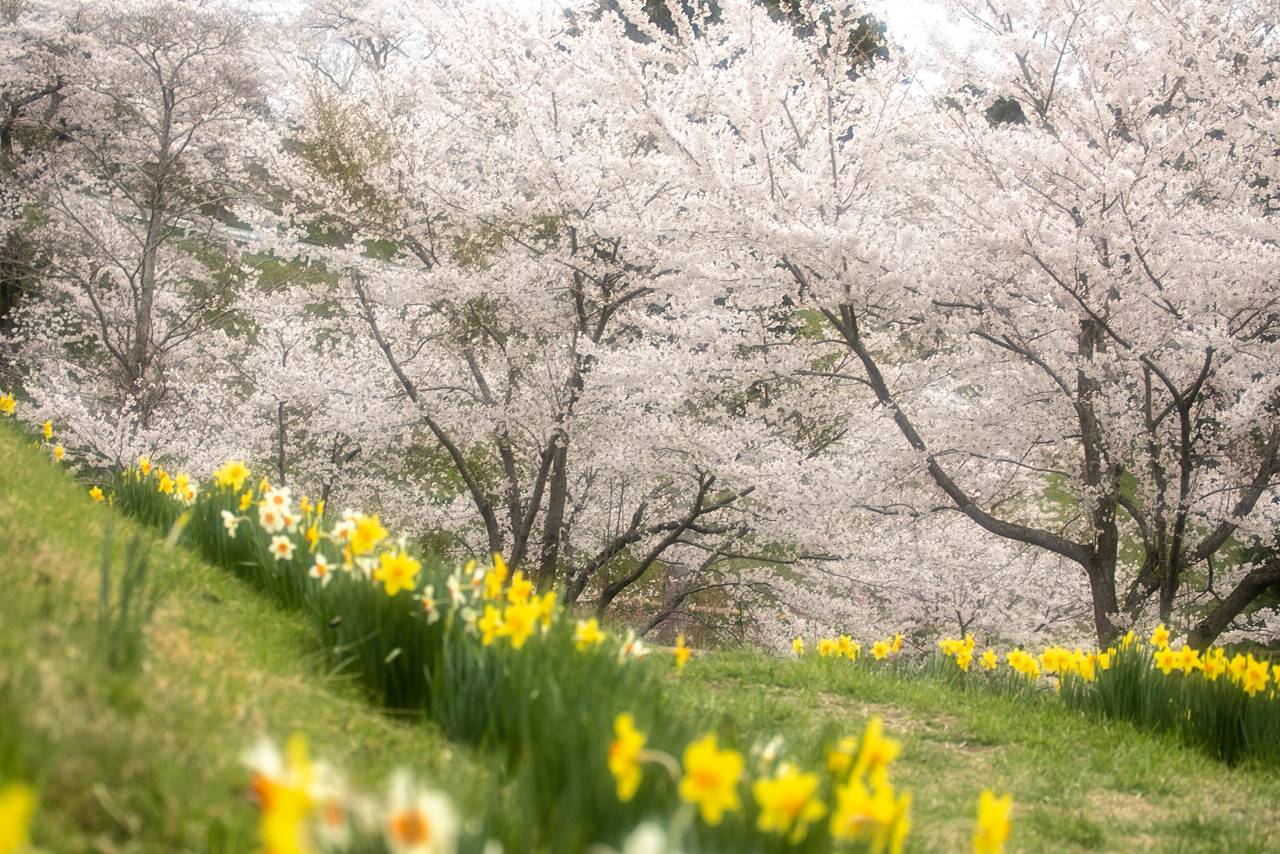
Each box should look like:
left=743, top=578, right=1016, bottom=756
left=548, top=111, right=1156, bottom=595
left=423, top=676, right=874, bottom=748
left=599, top=0, right=1277, bottom=643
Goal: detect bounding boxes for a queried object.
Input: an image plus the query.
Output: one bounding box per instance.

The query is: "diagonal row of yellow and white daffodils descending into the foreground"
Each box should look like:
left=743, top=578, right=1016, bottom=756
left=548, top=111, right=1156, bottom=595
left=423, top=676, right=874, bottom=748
left=0, top=414, right=1011, bottom=854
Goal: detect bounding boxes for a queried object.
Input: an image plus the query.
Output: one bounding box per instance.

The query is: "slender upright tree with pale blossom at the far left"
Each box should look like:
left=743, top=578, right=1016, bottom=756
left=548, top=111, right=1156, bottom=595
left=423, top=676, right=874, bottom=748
left=8, top=0, right=280, bottom=458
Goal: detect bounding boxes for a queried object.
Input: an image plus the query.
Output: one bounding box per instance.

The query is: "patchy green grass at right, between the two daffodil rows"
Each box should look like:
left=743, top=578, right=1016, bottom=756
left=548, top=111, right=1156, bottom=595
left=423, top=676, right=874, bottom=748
left=676, top=650, right=1280, bottom=851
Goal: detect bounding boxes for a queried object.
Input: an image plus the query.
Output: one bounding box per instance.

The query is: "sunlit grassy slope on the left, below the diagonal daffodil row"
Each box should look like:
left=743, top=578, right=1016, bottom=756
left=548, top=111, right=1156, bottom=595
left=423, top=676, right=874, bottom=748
left=0, top=424, right=486, bottom=853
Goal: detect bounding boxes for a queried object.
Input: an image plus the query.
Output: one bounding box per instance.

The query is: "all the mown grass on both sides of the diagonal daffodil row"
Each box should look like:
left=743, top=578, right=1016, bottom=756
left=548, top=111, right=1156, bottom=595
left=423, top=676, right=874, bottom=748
left=0, top=425, right=1280, bottom=851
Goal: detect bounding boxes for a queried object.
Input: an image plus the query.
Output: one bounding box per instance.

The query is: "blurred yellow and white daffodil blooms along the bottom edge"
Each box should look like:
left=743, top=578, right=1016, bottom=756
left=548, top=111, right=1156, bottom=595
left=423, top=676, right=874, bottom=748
left=230, top=713, right=1012, bottom=854
